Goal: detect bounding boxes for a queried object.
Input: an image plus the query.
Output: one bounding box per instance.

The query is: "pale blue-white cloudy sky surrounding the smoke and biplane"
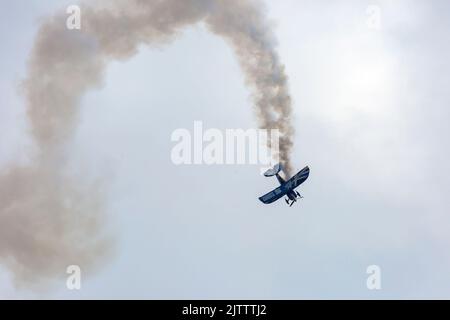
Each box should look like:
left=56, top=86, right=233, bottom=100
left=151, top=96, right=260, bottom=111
left=0, top=0, right=450, bottom=299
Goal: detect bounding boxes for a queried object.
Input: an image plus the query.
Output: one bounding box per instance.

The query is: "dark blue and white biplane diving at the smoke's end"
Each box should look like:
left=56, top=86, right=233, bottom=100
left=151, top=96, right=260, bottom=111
left=259, top=163, right=309, bottom=207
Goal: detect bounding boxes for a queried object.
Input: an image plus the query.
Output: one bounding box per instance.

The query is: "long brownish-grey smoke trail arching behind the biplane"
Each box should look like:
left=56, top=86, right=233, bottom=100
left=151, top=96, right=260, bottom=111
left=0, top=0, right=293, bottom=282
